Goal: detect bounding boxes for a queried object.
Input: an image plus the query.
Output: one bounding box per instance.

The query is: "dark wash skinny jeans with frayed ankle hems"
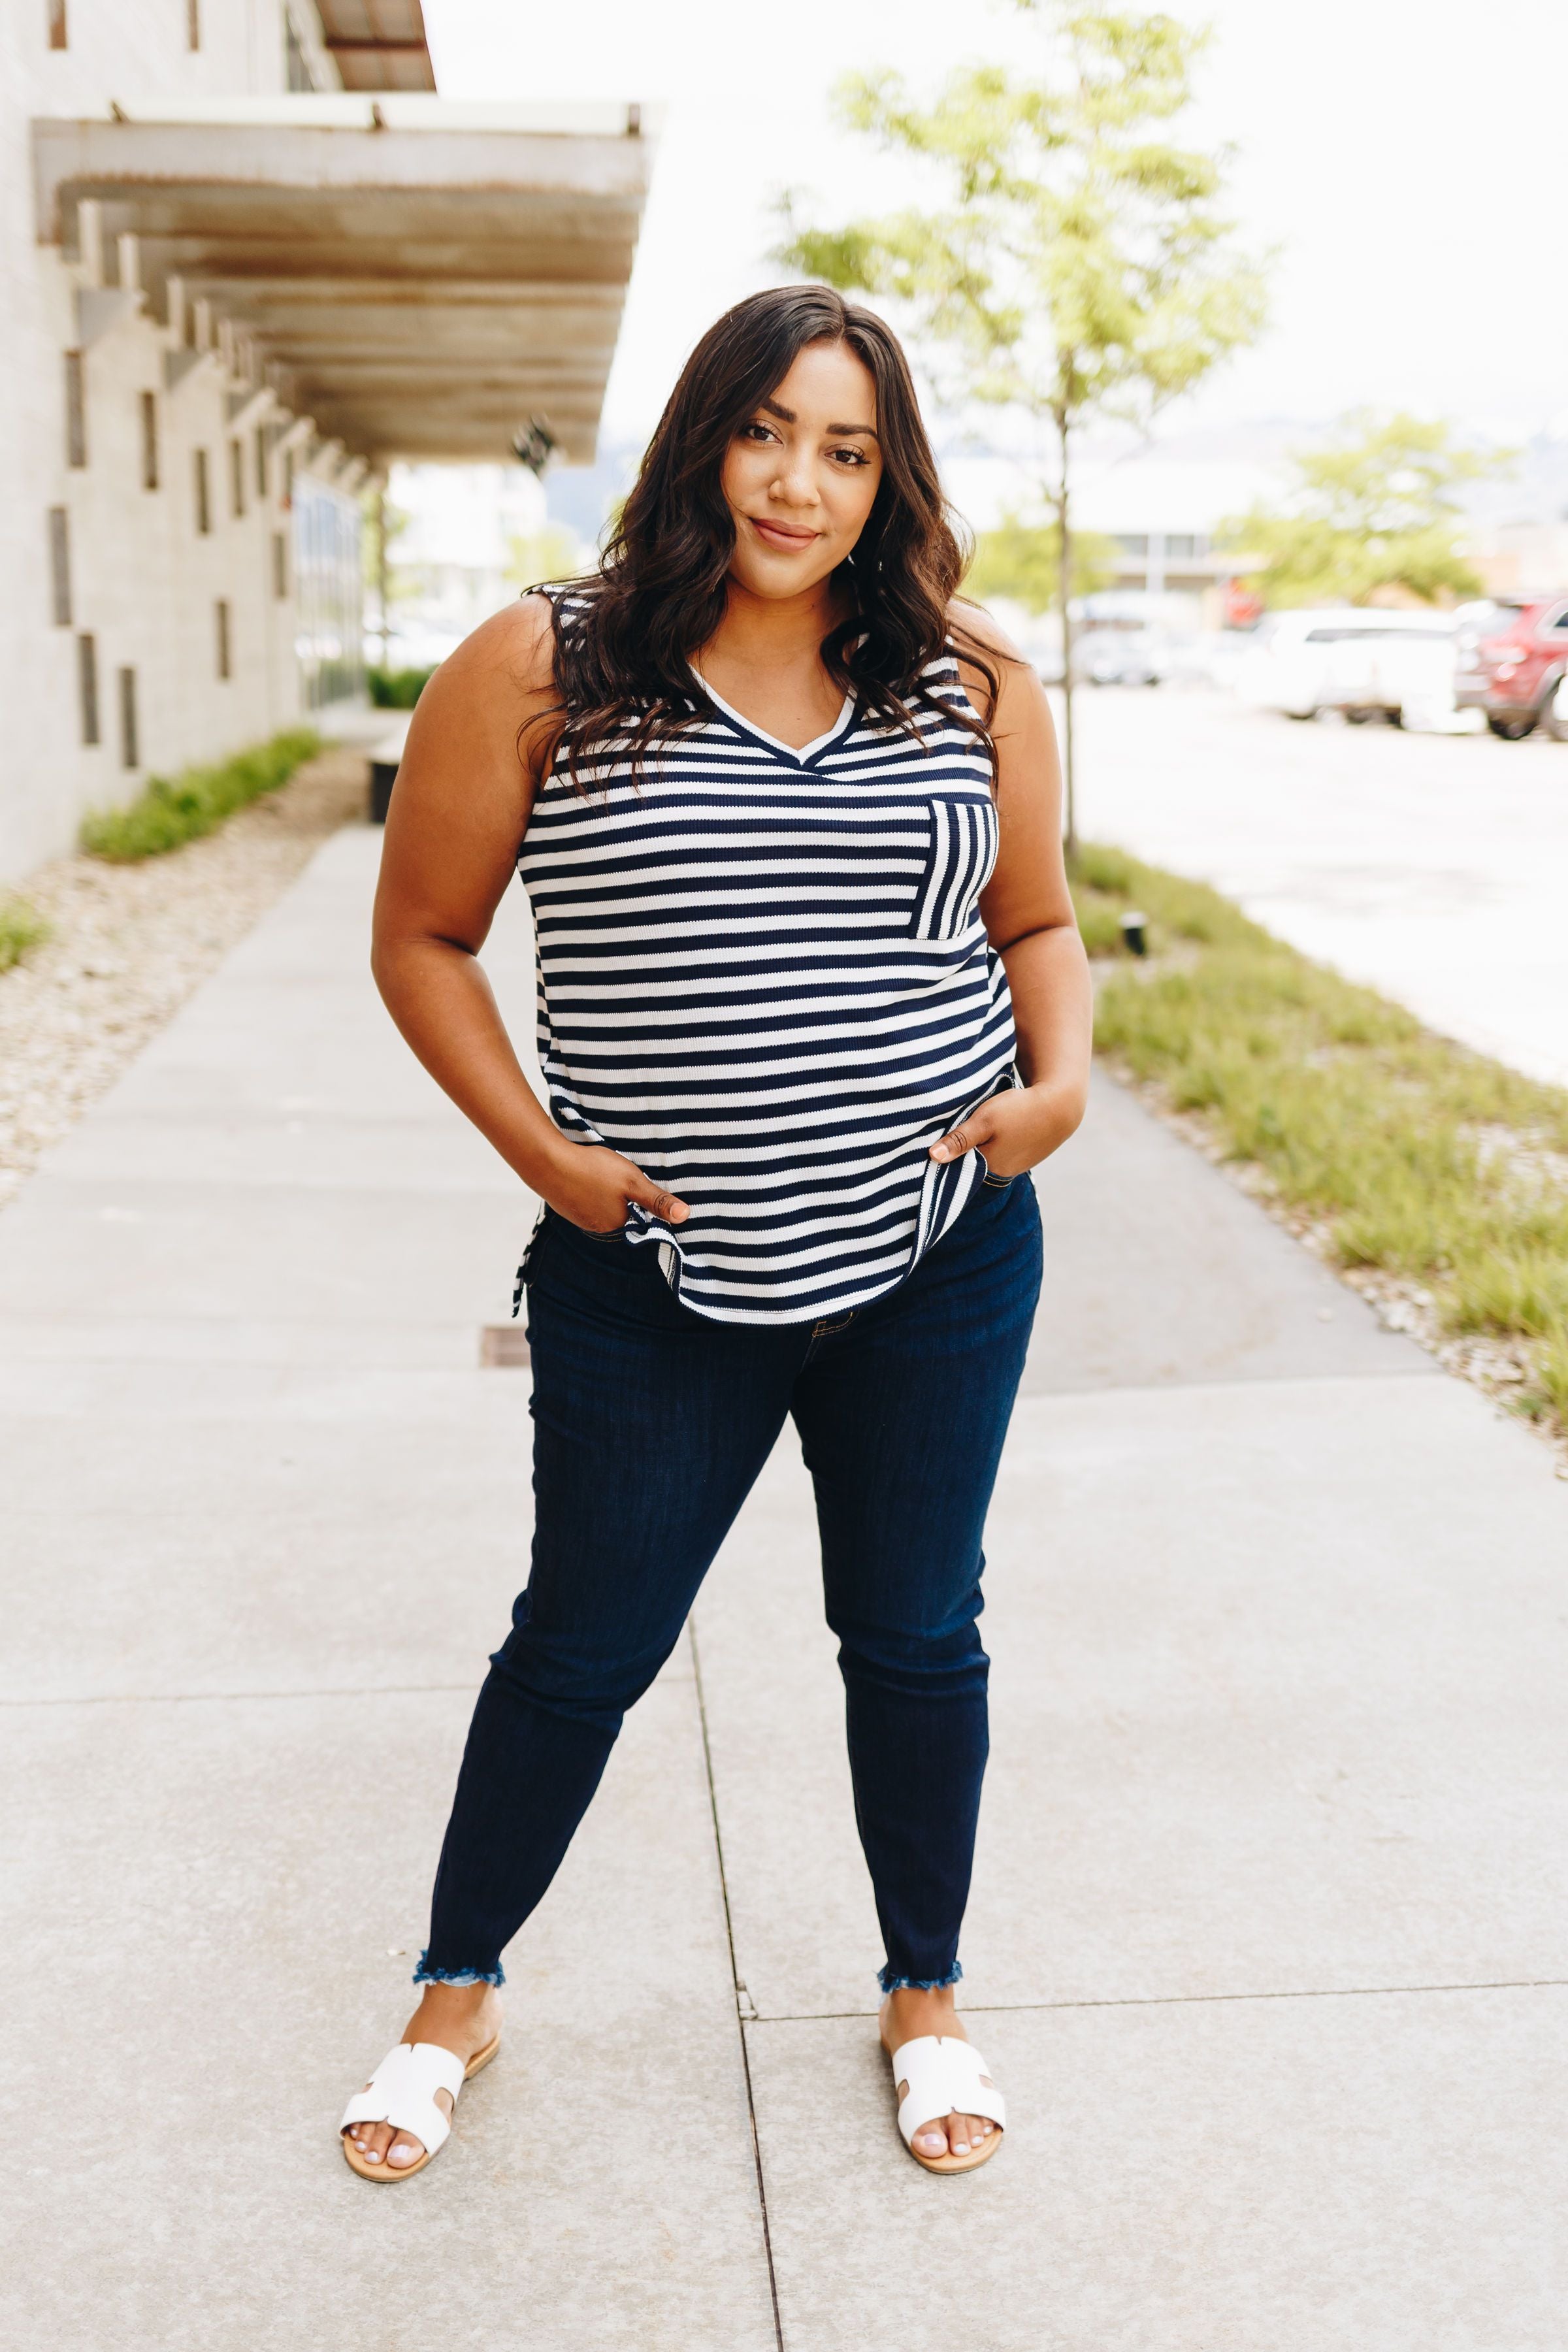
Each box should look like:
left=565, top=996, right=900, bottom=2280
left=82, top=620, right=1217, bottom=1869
left=414, top=1176, right=1041, bottom=1992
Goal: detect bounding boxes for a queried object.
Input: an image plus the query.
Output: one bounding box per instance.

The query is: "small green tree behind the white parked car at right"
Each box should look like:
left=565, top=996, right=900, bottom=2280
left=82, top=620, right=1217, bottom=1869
left=1222, top=409, right=1512, bottom=604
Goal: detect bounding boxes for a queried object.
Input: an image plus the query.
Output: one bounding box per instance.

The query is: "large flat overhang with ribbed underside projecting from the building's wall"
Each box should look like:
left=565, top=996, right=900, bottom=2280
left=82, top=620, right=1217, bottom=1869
left=33, top=91, right=651, bottom=466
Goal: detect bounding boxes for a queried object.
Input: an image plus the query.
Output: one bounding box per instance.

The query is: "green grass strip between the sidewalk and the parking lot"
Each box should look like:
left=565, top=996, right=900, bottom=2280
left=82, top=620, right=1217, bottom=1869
left=1072, top=844, right=1568, bottom=1430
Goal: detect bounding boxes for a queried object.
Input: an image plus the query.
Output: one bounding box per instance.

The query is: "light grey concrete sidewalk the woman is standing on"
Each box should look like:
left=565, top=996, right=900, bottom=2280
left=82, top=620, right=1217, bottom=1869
left=0, top=830, right=1568, bottom=2352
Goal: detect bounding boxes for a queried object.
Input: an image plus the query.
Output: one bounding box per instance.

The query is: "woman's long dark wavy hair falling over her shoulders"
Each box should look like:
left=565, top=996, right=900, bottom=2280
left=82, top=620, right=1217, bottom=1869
left=526, top=285, right=997, bottom=791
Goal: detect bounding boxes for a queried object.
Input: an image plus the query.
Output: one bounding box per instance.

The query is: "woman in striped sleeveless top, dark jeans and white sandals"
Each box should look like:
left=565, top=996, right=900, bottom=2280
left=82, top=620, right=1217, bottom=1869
left=343, top=287, right=1091, bottom=2180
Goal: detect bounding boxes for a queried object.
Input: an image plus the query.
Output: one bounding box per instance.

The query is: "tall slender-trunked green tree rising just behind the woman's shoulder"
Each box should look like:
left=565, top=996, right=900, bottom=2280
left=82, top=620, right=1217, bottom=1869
left=778, top=0, right=1262, bottom=842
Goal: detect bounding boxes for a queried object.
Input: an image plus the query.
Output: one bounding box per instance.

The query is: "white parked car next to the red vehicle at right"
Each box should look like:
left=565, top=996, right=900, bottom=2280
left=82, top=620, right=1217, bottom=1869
left=1237, top=604, right=1455, bottom=727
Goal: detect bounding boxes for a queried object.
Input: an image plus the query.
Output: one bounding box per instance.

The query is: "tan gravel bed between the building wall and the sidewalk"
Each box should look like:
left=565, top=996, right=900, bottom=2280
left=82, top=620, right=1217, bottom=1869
left=0, top=750, right=367, bottom=1204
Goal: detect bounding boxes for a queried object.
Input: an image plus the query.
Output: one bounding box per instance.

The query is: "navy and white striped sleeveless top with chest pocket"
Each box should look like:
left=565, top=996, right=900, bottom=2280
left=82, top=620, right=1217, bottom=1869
left=517, top=625, right=1015, bottom=1324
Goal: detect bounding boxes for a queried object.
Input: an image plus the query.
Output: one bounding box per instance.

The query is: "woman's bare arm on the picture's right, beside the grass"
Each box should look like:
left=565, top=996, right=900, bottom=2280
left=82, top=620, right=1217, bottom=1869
left=931, top=604, right=1093, bottom=1176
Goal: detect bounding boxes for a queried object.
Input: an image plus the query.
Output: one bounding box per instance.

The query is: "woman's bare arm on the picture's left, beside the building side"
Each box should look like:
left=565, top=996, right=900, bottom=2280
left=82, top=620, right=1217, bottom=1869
left=372, top=597, right=687, bottom=1232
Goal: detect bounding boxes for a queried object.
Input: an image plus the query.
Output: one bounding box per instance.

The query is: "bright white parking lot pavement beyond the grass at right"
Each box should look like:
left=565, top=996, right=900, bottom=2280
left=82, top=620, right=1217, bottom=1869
left=1074, top=687, right=1568, bottom=1085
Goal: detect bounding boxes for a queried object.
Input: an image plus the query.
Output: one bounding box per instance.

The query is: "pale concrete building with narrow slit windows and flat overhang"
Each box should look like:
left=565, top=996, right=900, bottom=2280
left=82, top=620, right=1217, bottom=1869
left=0, top=0, right=649, bottom=879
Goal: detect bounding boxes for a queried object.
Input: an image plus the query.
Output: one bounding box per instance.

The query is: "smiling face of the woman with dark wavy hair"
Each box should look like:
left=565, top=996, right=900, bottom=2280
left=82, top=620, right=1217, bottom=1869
left=719, top=344, right=881, bottom=597
